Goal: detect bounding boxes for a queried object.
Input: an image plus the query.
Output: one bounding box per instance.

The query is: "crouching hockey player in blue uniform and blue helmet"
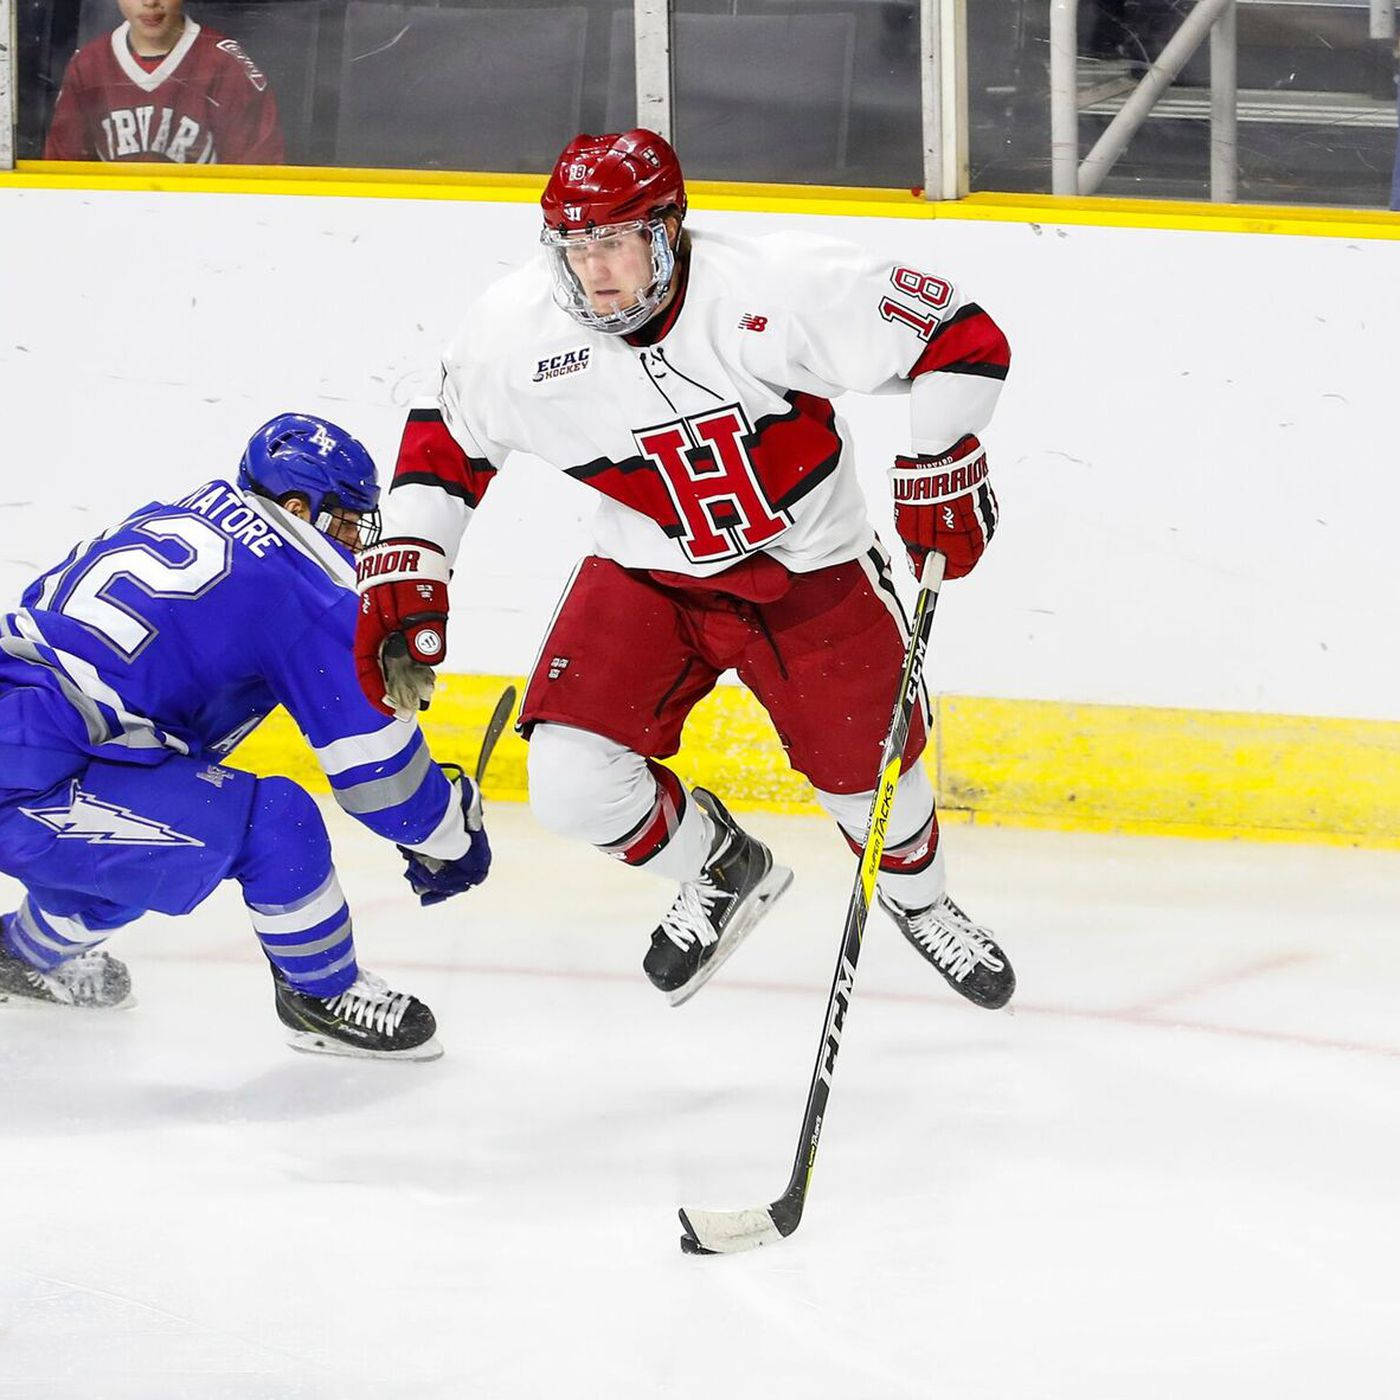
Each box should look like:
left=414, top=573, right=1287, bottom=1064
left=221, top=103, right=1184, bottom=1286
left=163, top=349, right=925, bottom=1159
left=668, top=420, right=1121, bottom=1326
left=0, top=413, right=490, bottom=1060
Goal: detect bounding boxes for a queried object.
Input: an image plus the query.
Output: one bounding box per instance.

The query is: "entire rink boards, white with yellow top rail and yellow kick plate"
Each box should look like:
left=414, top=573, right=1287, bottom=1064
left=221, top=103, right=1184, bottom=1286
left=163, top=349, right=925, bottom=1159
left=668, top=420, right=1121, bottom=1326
left=0, top=162, right=1400, bottom=846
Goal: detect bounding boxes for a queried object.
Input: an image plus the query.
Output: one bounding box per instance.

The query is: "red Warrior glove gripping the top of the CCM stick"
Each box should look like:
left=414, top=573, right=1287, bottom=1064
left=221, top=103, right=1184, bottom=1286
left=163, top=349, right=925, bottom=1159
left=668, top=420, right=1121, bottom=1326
left=889, top=433, right=997, bottom=578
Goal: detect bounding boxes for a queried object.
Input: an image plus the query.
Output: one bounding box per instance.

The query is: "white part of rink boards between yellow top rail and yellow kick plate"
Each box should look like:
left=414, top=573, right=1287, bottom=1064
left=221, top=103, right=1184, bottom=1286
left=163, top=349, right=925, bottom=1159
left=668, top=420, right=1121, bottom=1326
left=0, top=190, right=1400, bottom=720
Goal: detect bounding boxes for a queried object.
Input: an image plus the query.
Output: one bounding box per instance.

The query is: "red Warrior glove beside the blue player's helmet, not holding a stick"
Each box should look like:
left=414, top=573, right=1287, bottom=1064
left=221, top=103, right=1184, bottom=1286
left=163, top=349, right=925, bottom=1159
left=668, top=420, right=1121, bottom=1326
left=354, top=539, right=449, bottom=718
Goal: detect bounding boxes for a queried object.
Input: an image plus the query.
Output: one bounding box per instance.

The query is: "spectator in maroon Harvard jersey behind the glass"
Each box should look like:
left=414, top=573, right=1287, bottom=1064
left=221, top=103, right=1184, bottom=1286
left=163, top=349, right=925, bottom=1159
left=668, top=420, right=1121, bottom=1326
left=43, top=0, right=284, bottom=165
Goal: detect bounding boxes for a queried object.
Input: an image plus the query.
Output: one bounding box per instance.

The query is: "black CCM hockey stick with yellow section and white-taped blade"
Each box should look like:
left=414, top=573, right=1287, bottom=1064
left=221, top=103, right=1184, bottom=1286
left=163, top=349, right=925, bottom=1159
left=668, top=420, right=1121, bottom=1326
left=680, top=554, right=945, bottom=1254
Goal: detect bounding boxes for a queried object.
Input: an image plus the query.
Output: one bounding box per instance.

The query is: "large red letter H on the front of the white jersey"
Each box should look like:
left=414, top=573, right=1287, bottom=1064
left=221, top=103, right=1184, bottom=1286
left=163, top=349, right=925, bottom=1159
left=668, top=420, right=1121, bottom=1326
left=636, top=403, right=791, bottom=564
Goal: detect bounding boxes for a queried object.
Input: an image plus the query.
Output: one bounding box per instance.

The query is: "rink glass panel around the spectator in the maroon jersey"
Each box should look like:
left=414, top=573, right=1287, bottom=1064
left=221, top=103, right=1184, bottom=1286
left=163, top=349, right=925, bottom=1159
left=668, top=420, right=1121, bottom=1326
left=18, top=0, right=631, bottom=174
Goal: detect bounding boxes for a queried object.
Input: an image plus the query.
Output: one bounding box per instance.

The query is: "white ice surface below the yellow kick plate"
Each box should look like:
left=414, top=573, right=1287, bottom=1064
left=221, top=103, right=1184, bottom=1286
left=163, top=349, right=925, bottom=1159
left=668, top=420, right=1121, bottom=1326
left=0, top=806, right=1400, bottom=1400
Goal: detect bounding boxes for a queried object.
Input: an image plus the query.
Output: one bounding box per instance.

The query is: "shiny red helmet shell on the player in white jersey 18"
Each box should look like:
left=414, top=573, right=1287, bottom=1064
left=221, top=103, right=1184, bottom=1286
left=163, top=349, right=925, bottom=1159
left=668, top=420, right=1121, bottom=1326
left=539, top=127, right=686, bottom=234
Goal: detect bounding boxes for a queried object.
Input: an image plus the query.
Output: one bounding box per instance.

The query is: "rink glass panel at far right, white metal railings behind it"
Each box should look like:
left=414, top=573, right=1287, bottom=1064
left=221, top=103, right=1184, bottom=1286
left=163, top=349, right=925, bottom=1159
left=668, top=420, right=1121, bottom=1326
left=967, top=0, right=1396, bottom=209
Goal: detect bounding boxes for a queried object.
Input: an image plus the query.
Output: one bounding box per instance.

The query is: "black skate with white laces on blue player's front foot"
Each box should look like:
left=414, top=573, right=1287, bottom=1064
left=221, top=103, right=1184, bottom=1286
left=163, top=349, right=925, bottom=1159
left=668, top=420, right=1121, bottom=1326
left=272, top=967, right=442, bottom=1060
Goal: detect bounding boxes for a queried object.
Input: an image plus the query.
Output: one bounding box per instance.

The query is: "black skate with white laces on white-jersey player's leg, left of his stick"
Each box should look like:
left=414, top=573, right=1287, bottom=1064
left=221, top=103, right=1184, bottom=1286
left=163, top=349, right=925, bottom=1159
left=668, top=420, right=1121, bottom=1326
left=641, top=788, right=792, bottom=1007
